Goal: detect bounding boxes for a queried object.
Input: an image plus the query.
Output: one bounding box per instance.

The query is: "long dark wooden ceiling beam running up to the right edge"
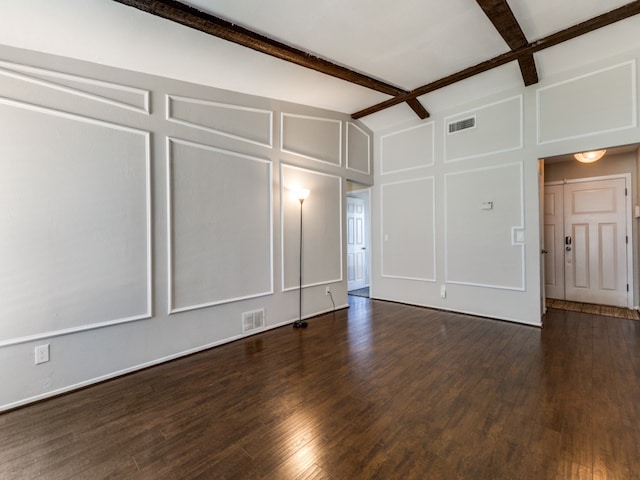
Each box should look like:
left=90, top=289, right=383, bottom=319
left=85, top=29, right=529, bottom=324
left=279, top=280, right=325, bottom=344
left=351, top=0, right=640, bottom=119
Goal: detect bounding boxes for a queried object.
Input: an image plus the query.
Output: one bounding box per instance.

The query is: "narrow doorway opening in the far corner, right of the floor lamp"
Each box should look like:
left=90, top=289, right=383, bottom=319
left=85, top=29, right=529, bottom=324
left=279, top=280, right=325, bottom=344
left=347, top=182, right=371, bottom=297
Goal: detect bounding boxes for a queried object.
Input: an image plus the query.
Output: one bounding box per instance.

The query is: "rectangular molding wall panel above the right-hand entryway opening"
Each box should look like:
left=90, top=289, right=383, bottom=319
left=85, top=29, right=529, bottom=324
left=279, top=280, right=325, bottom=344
left=536, top=60, right=638, bottom=144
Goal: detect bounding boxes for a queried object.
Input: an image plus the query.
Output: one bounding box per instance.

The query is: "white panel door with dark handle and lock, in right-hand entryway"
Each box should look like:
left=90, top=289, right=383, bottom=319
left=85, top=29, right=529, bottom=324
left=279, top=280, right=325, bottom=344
left=563, top=178, right=627, bottom=307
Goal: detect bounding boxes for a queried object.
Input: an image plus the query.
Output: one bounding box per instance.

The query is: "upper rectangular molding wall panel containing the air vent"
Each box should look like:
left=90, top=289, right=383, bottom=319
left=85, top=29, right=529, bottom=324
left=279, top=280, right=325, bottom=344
left=444, top=95, right=524, bottom=163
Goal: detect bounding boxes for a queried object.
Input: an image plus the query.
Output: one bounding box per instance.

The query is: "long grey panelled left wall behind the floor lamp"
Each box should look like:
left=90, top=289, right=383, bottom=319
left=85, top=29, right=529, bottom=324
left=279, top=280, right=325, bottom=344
left=0, top=46, right=372, bottom=410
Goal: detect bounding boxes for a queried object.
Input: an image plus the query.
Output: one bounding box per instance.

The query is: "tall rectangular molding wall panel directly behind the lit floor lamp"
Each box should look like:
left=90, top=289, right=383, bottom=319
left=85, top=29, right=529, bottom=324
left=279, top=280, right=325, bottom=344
left=280, top=163, right=343, bottom=292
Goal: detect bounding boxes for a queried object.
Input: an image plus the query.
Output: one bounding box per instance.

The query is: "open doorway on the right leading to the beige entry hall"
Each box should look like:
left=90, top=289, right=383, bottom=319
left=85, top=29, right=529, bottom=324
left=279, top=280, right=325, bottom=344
left=540, top=145, right=640, bottom=309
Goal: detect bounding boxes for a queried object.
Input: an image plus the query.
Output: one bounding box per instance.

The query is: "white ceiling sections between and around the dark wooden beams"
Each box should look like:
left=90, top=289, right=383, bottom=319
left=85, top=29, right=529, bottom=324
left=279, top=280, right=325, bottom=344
left=0, top=0, right=640, bottom=130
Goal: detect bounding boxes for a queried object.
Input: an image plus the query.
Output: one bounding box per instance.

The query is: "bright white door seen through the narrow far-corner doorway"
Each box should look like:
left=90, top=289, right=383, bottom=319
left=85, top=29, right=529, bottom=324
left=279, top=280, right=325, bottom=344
left=347, top=197, right=367, bottom=291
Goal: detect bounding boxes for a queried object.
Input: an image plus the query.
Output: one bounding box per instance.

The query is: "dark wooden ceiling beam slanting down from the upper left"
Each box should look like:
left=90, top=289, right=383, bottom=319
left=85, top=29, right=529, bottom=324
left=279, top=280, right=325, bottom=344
left=114, top=0, right=429, bottom=118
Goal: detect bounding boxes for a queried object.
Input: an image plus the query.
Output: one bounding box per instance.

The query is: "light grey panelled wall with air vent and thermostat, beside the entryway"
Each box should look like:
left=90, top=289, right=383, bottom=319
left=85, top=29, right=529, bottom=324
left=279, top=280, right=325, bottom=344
left=372, top=52, right=640, bottom=325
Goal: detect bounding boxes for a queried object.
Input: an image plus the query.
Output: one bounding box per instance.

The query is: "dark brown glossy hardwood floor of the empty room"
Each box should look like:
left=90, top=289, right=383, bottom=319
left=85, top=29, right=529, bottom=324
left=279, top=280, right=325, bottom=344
left=0, top=297, right=640, bottom=480
